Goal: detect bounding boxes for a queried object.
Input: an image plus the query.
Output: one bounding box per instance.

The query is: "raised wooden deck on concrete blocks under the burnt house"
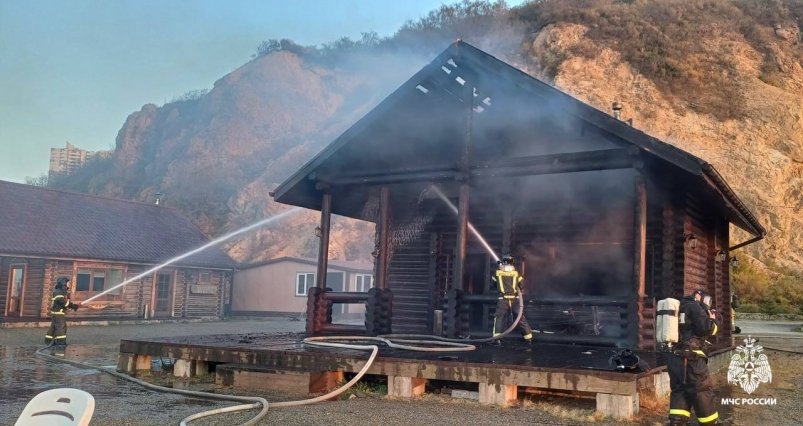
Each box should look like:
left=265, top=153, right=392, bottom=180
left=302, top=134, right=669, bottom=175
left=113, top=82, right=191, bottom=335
left=118, top=333, right=668, bottom=417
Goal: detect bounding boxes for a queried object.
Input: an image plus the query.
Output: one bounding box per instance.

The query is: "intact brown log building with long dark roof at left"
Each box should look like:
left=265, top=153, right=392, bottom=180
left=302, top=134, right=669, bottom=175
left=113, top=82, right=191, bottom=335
left=0, top=181, right=237, bottom=323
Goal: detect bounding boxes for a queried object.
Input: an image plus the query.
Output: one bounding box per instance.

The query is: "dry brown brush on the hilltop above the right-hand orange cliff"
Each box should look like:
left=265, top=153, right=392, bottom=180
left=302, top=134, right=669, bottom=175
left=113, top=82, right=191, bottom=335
left=513, top=0, right=803, bottom=120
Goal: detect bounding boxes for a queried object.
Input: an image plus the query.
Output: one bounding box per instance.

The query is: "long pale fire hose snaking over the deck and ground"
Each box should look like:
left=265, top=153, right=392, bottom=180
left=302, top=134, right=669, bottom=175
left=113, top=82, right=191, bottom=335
left=36, top=293, right=524, bottom=426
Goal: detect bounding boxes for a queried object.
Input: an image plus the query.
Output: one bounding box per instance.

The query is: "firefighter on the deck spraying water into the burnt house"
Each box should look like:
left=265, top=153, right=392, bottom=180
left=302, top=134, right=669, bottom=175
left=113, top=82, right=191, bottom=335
left=491, top=254, right=533, bottom=342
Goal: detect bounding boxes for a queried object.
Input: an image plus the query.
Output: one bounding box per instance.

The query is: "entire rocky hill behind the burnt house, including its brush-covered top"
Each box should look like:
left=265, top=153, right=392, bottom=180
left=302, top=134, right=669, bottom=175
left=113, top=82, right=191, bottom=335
left=57, top=0, right=803, bottom=282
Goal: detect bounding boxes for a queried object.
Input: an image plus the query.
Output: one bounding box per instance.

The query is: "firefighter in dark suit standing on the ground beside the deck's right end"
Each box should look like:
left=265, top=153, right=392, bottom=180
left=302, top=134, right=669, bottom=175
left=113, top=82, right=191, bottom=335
left=667, top=290, right=719, bottom=426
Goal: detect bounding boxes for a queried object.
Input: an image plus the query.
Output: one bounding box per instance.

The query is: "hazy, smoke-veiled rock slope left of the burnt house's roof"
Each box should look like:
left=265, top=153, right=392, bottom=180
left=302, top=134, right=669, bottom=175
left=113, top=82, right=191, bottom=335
left=104, top=51, right=436, bottom=261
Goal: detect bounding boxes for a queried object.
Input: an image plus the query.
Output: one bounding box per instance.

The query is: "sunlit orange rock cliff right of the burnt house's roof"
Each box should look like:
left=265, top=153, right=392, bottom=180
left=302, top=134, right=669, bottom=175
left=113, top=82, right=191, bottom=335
left=528, top=24, right=803, bottom=269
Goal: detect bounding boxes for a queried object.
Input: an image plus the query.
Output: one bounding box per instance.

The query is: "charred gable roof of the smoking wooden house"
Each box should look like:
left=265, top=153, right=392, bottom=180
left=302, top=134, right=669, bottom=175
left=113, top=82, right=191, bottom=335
left=273, top=41, right=766, bottom=238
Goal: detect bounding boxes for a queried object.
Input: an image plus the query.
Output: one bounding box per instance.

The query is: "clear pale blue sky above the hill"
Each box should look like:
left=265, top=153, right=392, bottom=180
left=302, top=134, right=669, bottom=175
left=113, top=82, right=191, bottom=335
left=0, top=0, right=521, bottom=183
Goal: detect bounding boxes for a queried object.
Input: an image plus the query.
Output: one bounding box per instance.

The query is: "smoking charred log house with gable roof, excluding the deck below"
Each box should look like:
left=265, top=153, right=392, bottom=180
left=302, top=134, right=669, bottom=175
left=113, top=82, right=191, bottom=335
left=273, top=41, right=765, bottom=349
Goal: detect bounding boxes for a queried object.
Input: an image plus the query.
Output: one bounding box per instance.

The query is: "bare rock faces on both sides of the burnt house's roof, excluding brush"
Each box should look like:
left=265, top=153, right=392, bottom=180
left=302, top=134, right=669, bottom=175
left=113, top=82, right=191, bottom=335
left=67, top=5, right=803, bottom=268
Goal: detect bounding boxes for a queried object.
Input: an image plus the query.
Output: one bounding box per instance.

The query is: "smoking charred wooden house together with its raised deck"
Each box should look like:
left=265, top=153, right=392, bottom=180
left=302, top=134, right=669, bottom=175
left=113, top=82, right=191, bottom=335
left=111, top=41, right=765, bottom=418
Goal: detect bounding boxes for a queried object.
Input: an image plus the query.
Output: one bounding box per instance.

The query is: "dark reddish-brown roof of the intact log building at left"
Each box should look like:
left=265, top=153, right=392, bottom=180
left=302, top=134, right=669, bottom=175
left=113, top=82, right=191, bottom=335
left=0, top=181, right=237, bottom=269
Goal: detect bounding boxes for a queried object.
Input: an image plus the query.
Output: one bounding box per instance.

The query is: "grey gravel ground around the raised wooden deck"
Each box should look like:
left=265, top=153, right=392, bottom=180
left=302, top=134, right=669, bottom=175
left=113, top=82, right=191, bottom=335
left=0, top=318, right=803, bottom=426
